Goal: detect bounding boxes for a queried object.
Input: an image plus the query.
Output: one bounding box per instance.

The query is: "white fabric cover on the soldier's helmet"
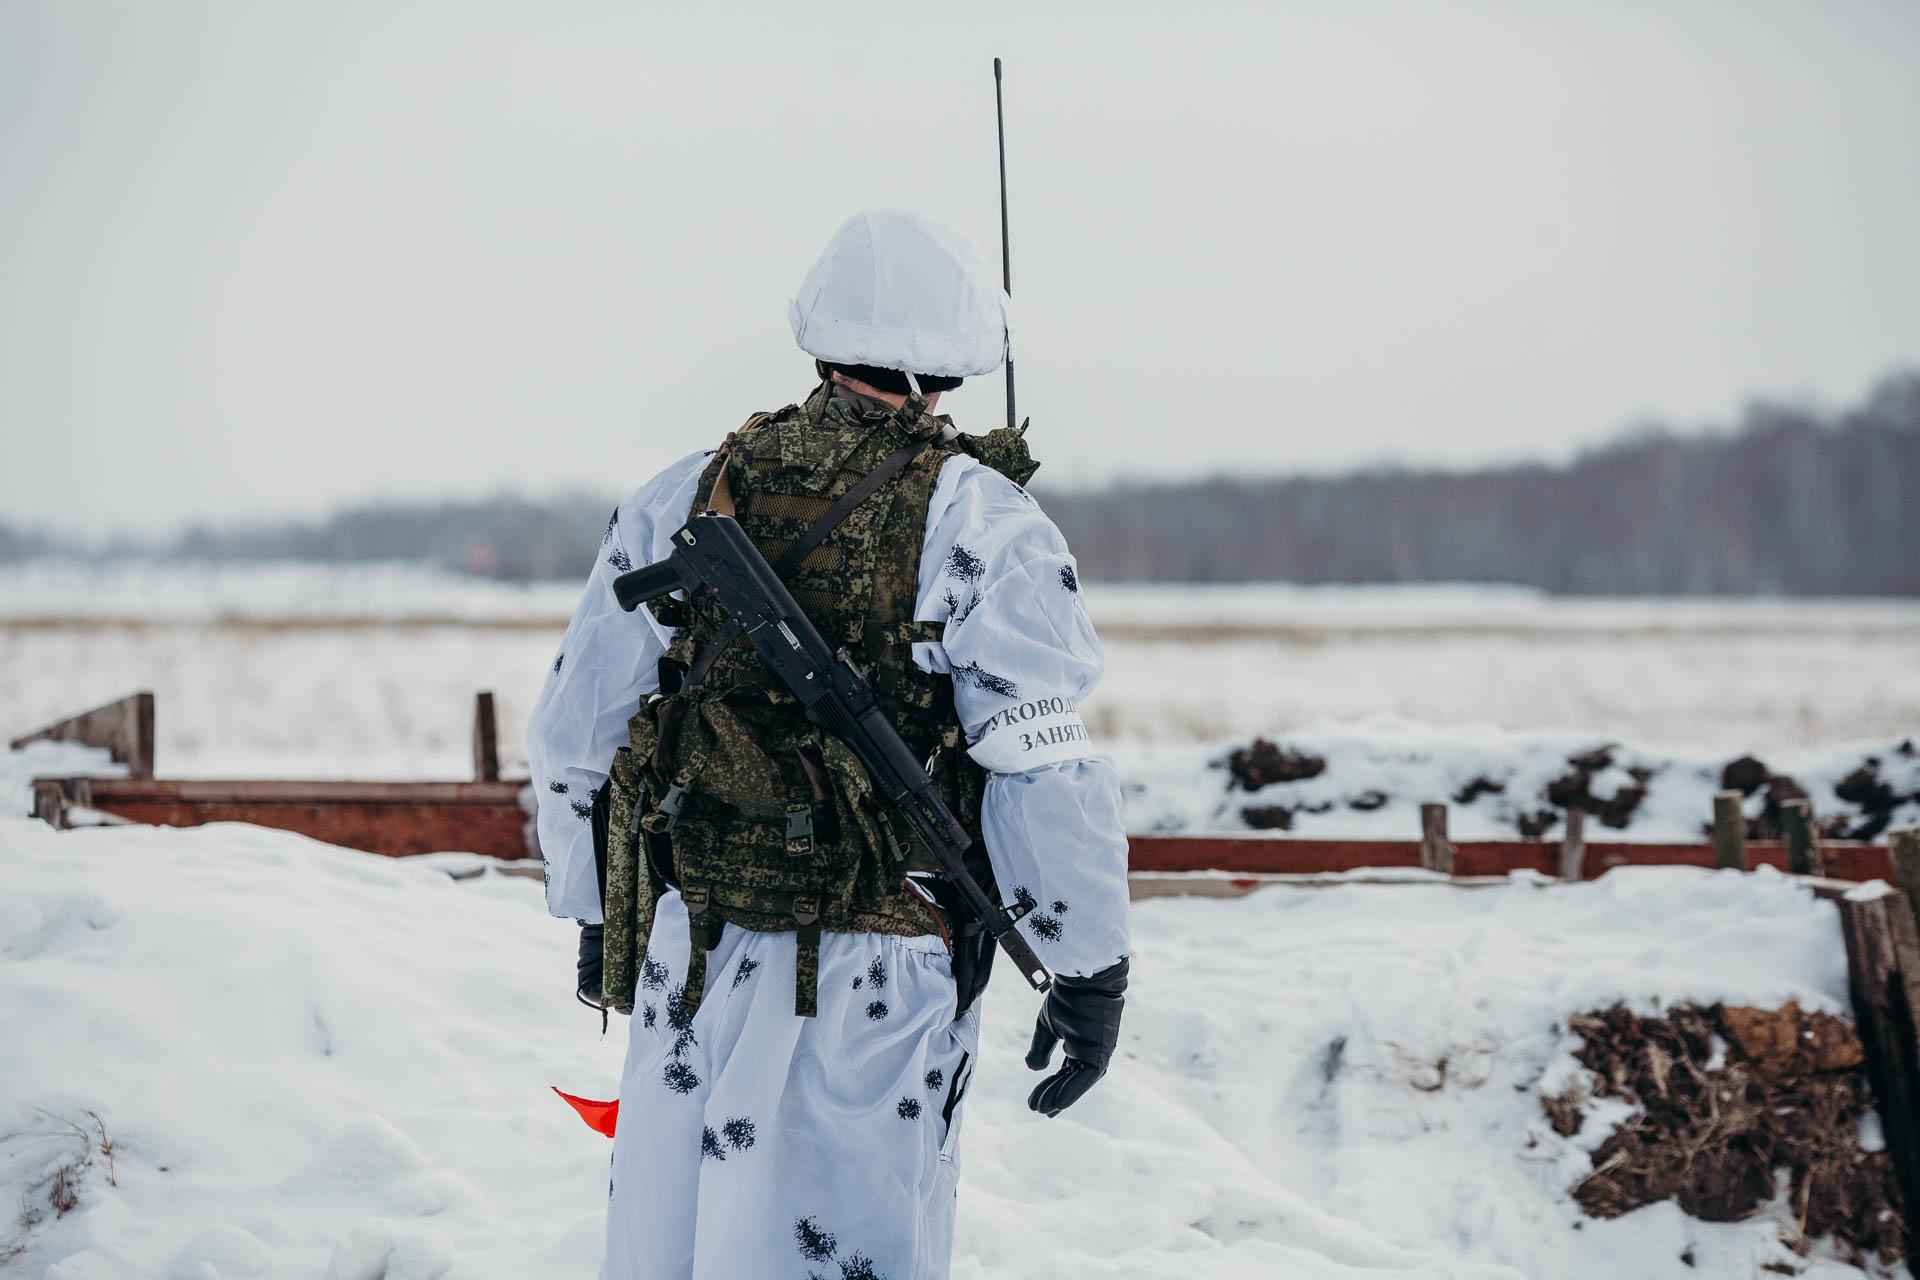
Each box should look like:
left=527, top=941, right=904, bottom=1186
left=787, top=209, right=1012, bottom=378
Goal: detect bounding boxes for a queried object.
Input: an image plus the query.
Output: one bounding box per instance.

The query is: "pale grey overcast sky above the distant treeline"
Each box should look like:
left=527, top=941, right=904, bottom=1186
left=0, top=0, right=1920, bottom=533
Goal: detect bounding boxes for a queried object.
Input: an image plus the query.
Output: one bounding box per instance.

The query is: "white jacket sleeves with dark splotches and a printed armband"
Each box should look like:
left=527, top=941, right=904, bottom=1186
left=526, top=451, right=1129, bottom=977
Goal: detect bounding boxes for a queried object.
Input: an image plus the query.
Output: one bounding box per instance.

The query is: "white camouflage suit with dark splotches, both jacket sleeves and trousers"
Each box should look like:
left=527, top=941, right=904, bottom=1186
left=528, top=441, right=1129, bottom=1280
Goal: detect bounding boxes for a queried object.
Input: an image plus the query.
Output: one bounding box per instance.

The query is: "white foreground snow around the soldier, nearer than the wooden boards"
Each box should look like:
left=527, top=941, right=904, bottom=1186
left=0, top=818, right=1889, bottom=1280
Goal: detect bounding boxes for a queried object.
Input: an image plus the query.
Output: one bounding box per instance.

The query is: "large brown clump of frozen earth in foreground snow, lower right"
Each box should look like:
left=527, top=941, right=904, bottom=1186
left=1542, top=1004, right=1903, bottom=1263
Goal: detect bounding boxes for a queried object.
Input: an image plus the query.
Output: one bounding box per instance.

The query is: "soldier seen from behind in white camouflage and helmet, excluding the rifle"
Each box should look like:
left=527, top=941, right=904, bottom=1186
left=528, top=211, right=1129, bottom=1280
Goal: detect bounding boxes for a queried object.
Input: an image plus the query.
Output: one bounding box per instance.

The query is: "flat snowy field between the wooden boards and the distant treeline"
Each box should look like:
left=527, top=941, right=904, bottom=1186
left=0, top=564, right=1920, bottom=777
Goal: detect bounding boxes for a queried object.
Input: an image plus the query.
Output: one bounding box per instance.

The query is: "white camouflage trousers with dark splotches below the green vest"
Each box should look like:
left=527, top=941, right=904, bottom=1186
left=601, top=892, right=979, bottom=1280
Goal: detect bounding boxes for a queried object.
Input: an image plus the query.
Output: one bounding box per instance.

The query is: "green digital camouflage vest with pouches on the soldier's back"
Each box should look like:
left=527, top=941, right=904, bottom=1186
left=601, top=386, right=1037, bottom=1015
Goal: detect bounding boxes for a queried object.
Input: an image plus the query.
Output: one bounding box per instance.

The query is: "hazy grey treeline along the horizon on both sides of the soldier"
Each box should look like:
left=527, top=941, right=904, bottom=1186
left=0, top=372, right=1920, bottom=595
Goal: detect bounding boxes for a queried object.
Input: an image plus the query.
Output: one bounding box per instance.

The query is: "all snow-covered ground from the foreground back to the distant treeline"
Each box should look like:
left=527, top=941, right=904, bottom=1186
left=0, top=566, right=1920, bottom=1280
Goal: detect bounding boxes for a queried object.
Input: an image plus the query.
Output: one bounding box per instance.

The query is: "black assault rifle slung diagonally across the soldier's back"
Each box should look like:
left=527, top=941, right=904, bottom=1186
left=612, top=510, right=1054, bottom=990
